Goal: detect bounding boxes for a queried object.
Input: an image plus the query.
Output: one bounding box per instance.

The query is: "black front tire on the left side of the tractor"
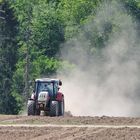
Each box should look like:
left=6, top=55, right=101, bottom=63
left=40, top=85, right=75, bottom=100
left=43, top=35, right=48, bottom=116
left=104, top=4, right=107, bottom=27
left=27, top=100, right=35, bottom=116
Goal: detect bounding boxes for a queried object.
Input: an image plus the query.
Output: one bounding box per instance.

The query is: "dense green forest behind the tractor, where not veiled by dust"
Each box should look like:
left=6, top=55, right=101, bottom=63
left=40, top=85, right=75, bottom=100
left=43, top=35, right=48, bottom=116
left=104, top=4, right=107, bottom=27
left=0, top=0, right=140, bottom=114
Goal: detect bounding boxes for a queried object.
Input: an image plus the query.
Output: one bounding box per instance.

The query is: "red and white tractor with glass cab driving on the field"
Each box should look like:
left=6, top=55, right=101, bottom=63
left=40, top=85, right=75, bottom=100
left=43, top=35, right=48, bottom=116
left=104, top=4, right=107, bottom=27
left=27, top=78, right=65, bottom=117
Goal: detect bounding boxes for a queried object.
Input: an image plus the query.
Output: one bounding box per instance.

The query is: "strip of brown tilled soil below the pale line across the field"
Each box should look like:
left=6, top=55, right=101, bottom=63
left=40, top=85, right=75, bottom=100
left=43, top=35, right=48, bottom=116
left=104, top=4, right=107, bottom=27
left=0, top=127, right=140, bottom=140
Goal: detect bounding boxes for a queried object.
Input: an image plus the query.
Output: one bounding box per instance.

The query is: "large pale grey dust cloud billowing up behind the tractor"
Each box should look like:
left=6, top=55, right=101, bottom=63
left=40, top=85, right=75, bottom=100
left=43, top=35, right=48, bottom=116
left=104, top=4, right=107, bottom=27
left=59, top=2, right=140, bottom=116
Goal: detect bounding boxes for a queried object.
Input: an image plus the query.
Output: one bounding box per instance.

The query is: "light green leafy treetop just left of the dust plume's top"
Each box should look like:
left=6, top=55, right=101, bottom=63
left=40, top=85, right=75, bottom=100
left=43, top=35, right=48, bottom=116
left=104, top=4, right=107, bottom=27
left=58, top=0, right=101, bottom=40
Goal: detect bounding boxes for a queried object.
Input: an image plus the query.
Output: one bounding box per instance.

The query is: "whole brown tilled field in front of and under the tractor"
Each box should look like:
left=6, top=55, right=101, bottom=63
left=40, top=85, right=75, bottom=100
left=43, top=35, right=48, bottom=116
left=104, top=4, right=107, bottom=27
left=0, top=115, right=140, bottom=140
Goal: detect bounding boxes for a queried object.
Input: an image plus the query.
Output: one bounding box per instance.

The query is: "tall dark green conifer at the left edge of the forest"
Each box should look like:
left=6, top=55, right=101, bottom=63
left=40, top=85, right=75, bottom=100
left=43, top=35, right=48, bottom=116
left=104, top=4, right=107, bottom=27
left=0, top=1, right=19, bottom=114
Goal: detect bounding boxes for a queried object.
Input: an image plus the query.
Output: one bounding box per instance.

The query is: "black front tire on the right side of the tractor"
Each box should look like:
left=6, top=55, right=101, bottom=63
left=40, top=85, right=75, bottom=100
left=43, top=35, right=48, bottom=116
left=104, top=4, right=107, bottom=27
left=50, top=101, right=59, bottom=117
